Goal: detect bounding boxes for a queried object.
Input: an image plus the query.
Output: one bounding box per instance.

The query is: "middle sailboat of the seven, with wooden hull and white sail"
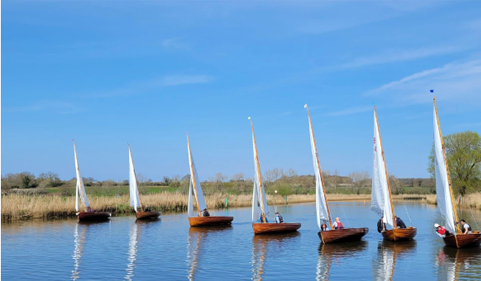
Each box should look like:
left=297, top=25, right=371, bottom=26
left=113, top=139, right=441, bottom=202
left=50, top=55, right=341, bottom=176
left=249, top=117, right=301, bottom=234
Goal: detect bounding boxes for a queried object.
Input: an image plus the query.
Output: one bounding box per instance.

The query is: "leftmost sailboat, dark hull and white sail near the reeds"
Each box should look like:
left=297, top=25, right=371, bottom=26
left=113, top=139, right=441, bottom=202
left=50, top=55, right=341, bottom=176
left=72, top=140, right=110, bottom=221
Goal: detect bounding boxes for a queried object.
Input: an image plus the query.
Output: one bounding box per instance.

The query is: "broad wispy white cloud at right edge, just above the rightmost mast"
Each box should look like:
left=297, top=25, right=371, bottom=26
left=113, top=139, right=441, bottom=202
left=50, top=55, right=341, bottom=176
left=364, top=58, right=481, bottom=105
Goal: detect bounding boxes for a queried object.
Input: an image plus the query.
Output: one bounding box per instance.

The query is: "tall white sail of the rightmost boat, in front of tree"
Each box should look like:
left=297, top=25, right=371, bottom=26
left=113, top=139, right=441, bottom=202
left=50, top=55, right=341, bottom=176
left=433, top=103, right=456, bottom=233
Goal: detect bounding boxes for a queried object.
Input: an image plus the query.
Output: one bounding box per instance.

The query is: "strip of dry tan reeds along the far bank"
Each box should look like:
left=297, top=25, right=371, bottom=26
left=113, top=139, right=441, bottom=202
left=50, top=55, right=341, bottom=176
left=1, top=192, right=481, bottom=223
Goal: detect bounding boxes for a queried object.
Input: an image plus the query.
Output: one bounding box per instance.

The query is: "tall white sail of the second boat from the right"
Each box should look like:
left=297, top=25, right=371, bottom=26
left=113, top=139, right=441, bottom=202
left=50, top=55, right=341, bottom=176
left=371, top=113, right=394, bottom=227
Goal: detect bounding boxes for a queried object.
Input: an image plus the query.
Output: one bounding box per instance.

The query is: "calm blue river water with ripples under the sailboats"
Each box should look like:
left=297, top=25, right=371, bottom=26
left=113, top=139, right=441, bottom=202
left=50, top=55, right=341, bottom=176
left=2, top=202, right=481, bottom=280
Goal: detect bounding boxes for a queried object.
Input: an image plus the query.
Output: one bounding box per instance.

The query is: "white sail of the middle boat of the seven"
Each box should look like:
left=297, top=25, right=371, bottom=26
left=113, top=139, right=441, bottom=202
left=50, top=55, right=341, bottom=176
left=252, top=126, right=268, bottom=222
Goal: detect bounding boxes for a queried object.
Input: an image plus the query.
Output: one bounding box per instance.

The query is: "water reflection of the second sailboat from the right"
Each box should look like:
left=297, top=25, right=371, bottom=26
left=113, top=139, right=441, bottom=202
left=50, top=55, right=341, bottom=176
left=372, top=240, right=416, bottom=280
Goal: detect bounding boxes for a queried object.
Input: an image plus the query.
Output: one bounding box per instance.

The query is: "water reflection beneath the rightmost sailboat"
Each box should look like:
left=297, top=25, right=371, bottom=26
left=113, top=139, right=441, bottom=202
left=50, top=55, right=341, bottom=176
left=435, top=246, right=481, bottom=281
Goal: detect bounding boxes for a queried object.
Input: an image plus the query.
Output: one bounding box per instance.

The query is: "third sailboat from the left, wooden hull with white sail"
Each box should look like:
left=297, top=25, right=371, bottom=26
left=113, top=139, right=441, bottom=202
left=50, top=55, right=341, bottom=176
left=187, top=132, right=234, bottom=226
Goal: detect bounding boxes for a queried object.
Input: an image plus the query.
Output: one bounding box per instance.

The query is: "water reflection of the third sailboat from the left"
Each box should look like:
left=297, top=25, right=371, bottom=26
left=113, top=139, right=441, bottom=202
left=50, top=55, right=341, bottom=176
left=187, top=225, right=232, bottom=280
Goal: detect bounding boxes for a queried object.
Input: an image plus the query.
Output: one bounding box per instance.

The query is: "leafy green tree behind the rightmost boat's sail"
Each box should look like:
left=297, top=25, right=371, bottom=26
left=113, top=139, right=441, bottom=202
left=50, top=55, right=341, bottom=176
left=428, top=131, right=481, bottom=196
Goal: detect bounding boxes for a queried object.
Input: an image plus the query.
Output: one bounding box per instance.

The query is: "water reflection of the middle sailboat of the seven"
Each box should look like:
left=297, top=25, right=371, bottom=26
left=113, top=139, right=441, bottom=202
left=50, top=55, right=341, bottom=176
left=251, top=232, right=300, bottom=280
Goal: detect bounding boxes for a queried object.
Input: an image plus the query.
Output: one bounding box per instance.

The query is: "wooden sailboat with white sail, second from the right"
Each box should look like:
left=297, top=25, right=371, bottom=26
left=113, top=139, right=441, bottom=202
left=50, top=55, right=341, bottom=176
left=371, top=107, right=417, bottom=241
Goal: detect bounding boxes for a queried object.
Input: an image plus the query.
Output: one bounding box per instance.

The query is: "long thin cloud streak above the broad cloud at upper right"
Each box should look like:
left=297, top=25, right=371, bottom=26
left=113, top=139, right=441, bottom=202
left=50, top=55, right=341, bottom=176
left=340, top=47, right=464, bottom=69
